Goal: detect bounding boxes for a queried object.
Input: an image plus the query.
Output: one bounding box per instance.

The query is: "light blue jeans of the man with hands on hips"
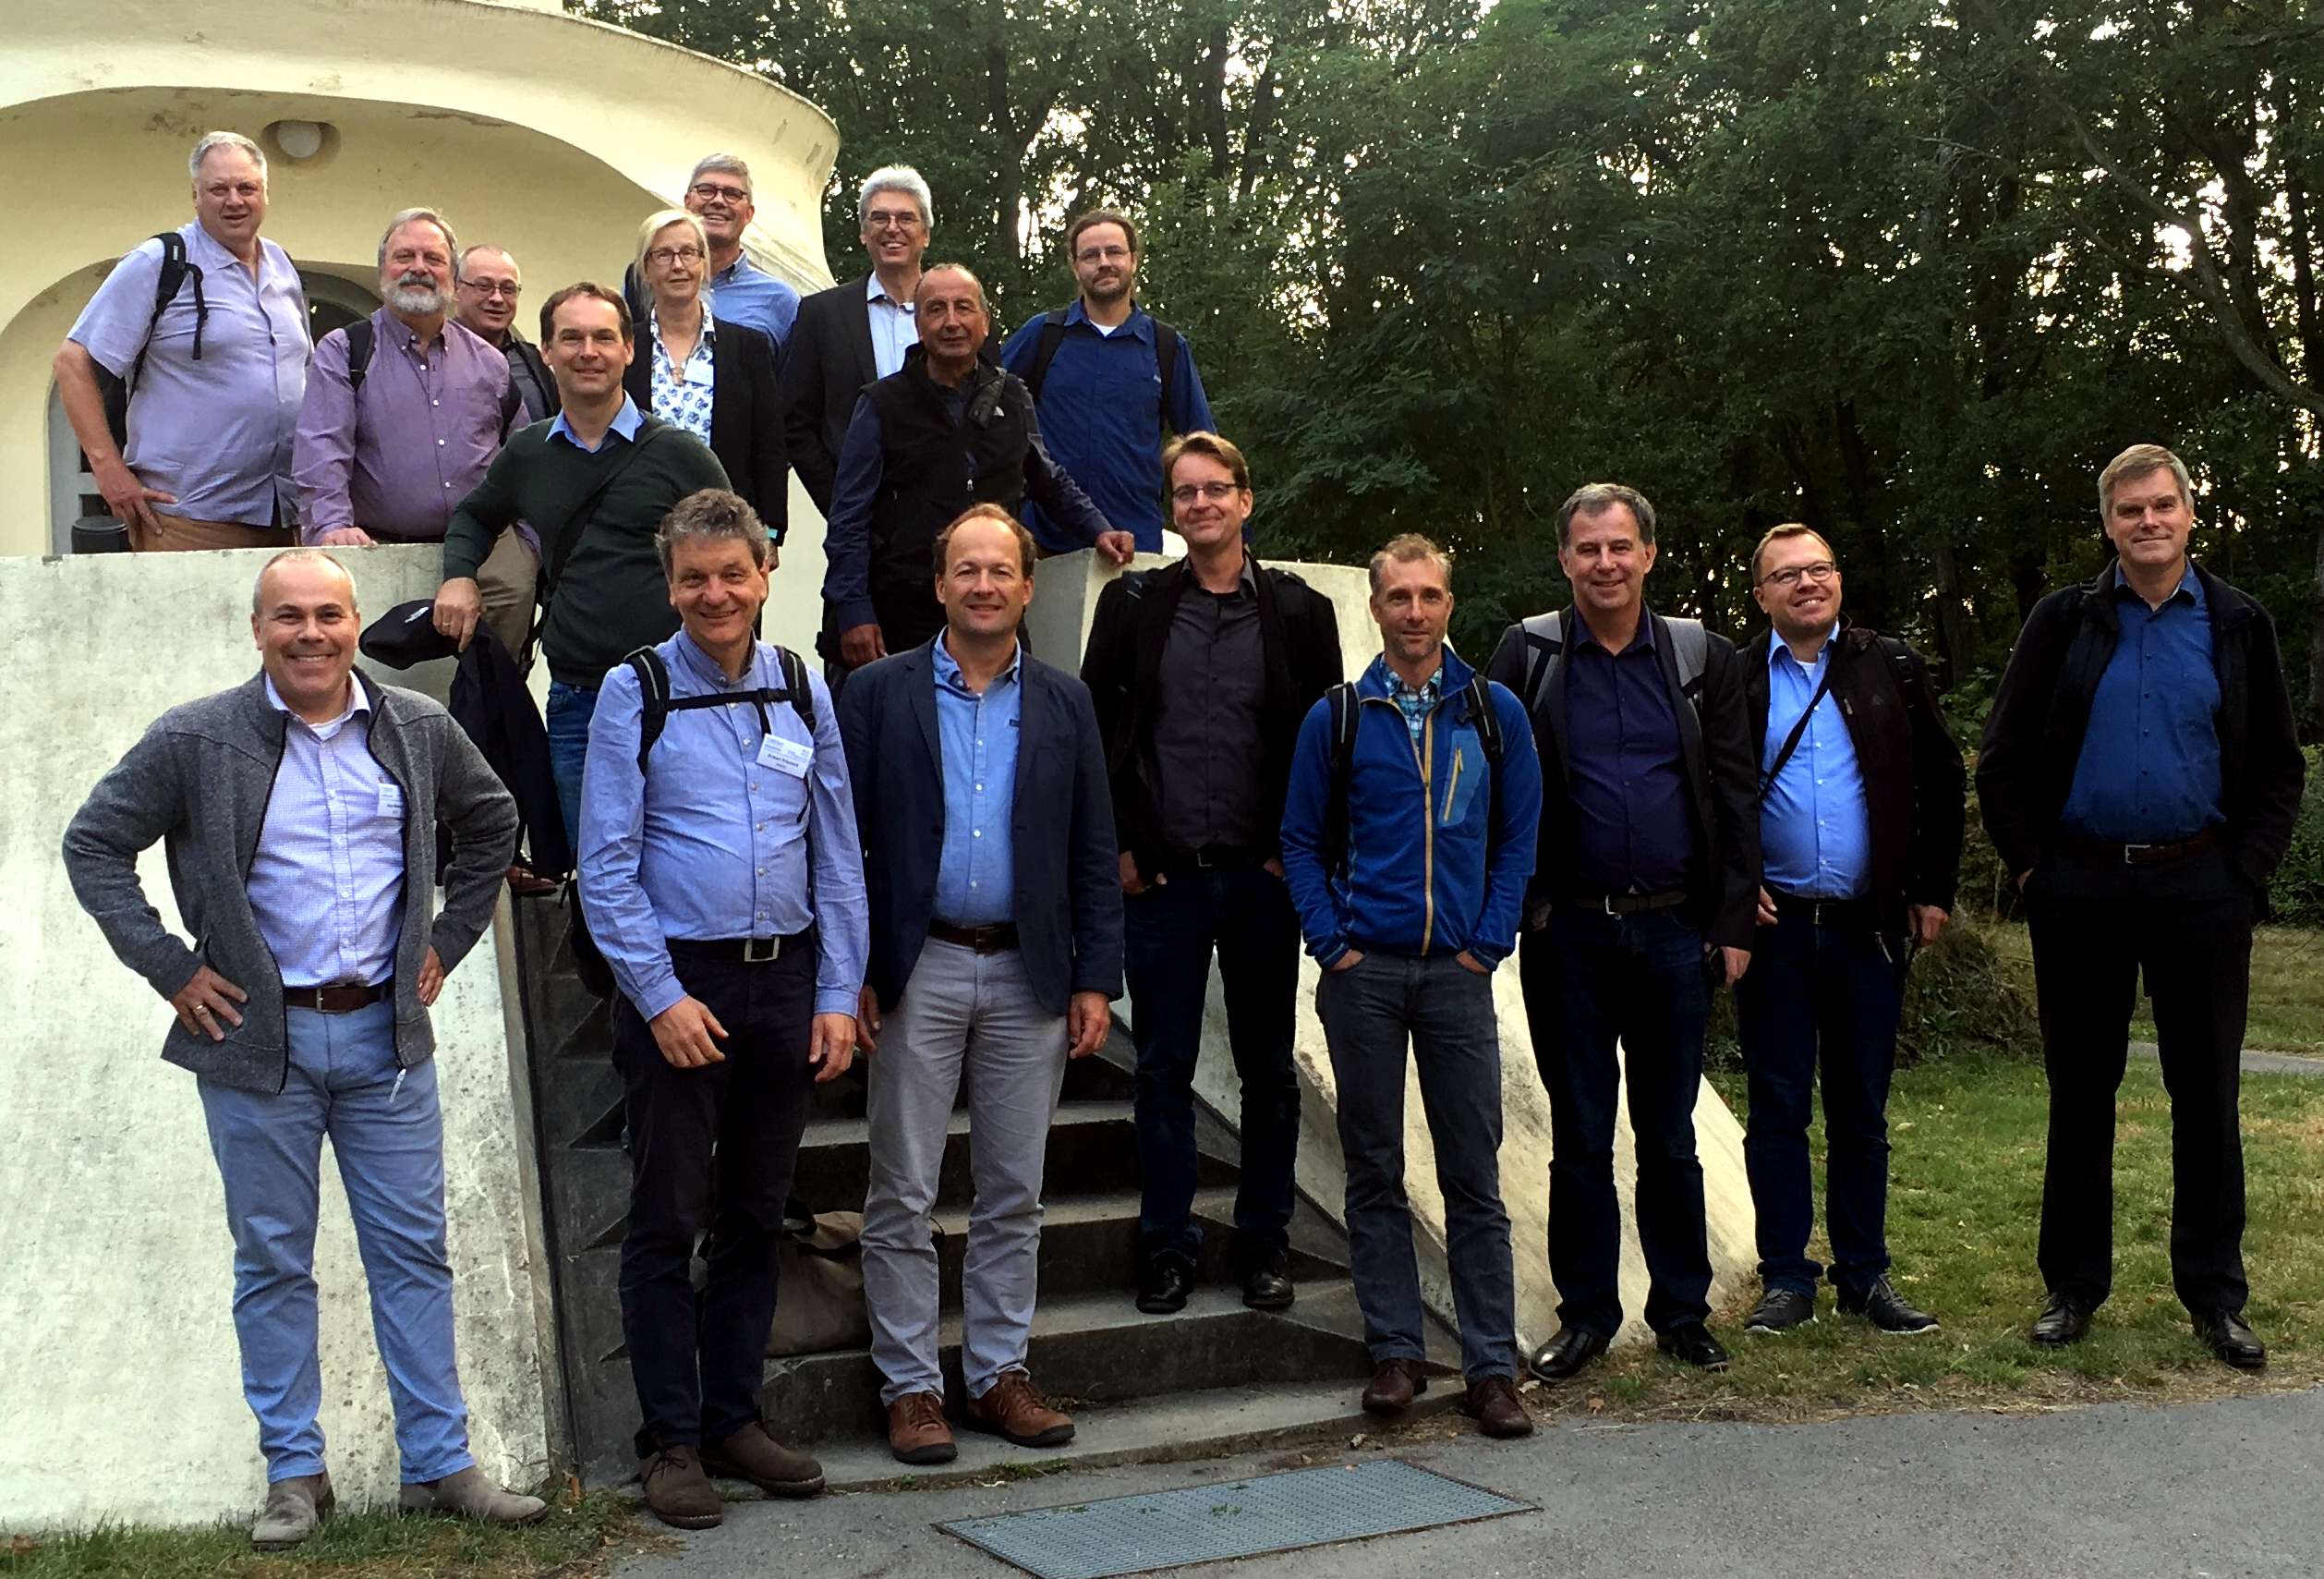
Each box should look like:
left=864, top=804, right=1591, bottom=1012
left=200, top=998, right=477, bottom=1484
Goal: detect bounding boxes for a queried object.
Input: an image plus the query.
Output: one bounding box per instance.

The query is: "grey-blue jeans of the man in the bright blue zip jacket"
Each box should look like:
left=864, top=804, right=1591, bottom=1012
left=1315, top=953, right=1518, bottom=1381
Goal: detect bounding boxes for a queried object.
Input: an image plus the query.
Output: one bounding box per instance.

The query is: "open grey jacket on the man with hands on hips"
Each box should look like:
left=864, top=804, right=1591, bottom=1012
left=65, top=674, right=516, bottom=1093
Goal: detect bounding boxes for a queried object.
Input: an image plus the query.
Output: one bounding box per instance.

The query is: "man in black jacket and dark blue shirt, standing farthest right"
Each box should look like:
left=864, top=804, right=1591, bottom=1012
left=1978, top=444, right=2303, bottom=1369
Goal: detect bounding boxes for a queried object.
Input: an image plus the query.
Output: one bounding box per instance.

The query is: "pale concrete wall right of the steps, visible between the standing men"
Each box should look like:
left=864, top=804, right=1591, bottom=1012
left=1027, top=553, right=1760, bottom=1351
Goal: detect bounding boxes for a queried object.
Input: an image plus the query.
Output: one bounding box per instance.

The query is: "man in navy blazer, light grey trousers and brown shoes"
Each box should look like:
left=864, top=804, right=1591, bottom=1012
left=839, top=504, right=1122, bottom=1463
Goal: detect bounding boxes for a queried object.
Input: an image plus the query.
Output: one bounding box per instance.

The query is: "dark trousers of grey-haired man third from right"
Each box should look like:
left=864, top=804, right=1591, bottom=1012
left=1518, top=905, right=1711, bottom=1337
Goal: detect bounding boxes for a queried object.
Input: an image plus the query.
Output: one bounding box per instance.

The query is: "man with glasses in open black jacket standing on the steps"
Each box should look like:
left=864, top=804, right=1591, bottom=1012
left=1081, top=432, right=1341, bottom=1314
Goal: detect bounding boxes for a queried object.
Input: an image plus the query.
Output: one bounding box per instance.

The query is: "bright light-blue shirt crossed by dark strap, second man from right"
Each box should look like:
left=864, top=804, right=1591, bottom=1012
left=1760, top=621, right=1873, bottom=900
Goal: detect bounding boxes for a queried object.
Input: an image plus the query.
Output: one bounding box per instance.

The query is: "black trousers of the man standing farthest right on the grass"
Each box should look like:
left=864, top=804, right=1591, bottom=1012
left=2027, top=849, right=2252, bottom=1312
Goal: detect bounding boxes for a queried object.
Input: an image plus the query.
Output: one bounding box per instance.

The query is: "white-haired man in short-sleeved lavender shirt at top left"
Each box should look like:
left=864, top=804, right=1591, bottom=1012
left=54, top=132, right=309, bottom=552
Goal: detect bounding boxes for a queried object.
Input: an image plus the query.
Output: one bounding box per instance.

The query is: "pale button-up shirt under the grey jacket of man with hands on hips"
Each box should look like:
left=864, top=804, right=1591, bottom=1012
left=248, top=676, right=405, bottom=986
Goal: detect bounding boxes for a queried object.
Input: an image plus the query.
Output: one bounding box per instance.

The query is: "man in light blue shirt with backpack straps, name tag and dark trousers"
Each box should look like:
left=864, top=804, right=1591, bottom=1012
left=578, top=489, right=869, bottom=1530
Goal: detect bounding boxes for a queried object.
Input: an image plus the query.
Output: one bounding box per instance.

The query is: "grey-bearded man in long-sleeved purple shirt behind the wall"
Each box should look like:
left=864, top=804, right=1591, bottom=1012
left=291, top=210, right=532, bottom=653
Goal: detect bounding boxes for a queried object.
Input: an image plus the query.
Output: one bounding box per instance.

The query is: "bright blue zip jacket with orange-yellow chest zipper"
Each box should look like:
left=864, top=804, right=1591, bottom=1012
left=1283, top=647, right=1541, bottom=970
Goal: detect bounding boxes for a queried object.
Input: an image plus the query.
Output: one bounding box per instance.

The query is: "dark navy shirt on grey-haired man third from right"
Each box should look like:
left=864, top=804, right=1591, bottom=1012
left=1564, top=612, right=1694, bottom=895
